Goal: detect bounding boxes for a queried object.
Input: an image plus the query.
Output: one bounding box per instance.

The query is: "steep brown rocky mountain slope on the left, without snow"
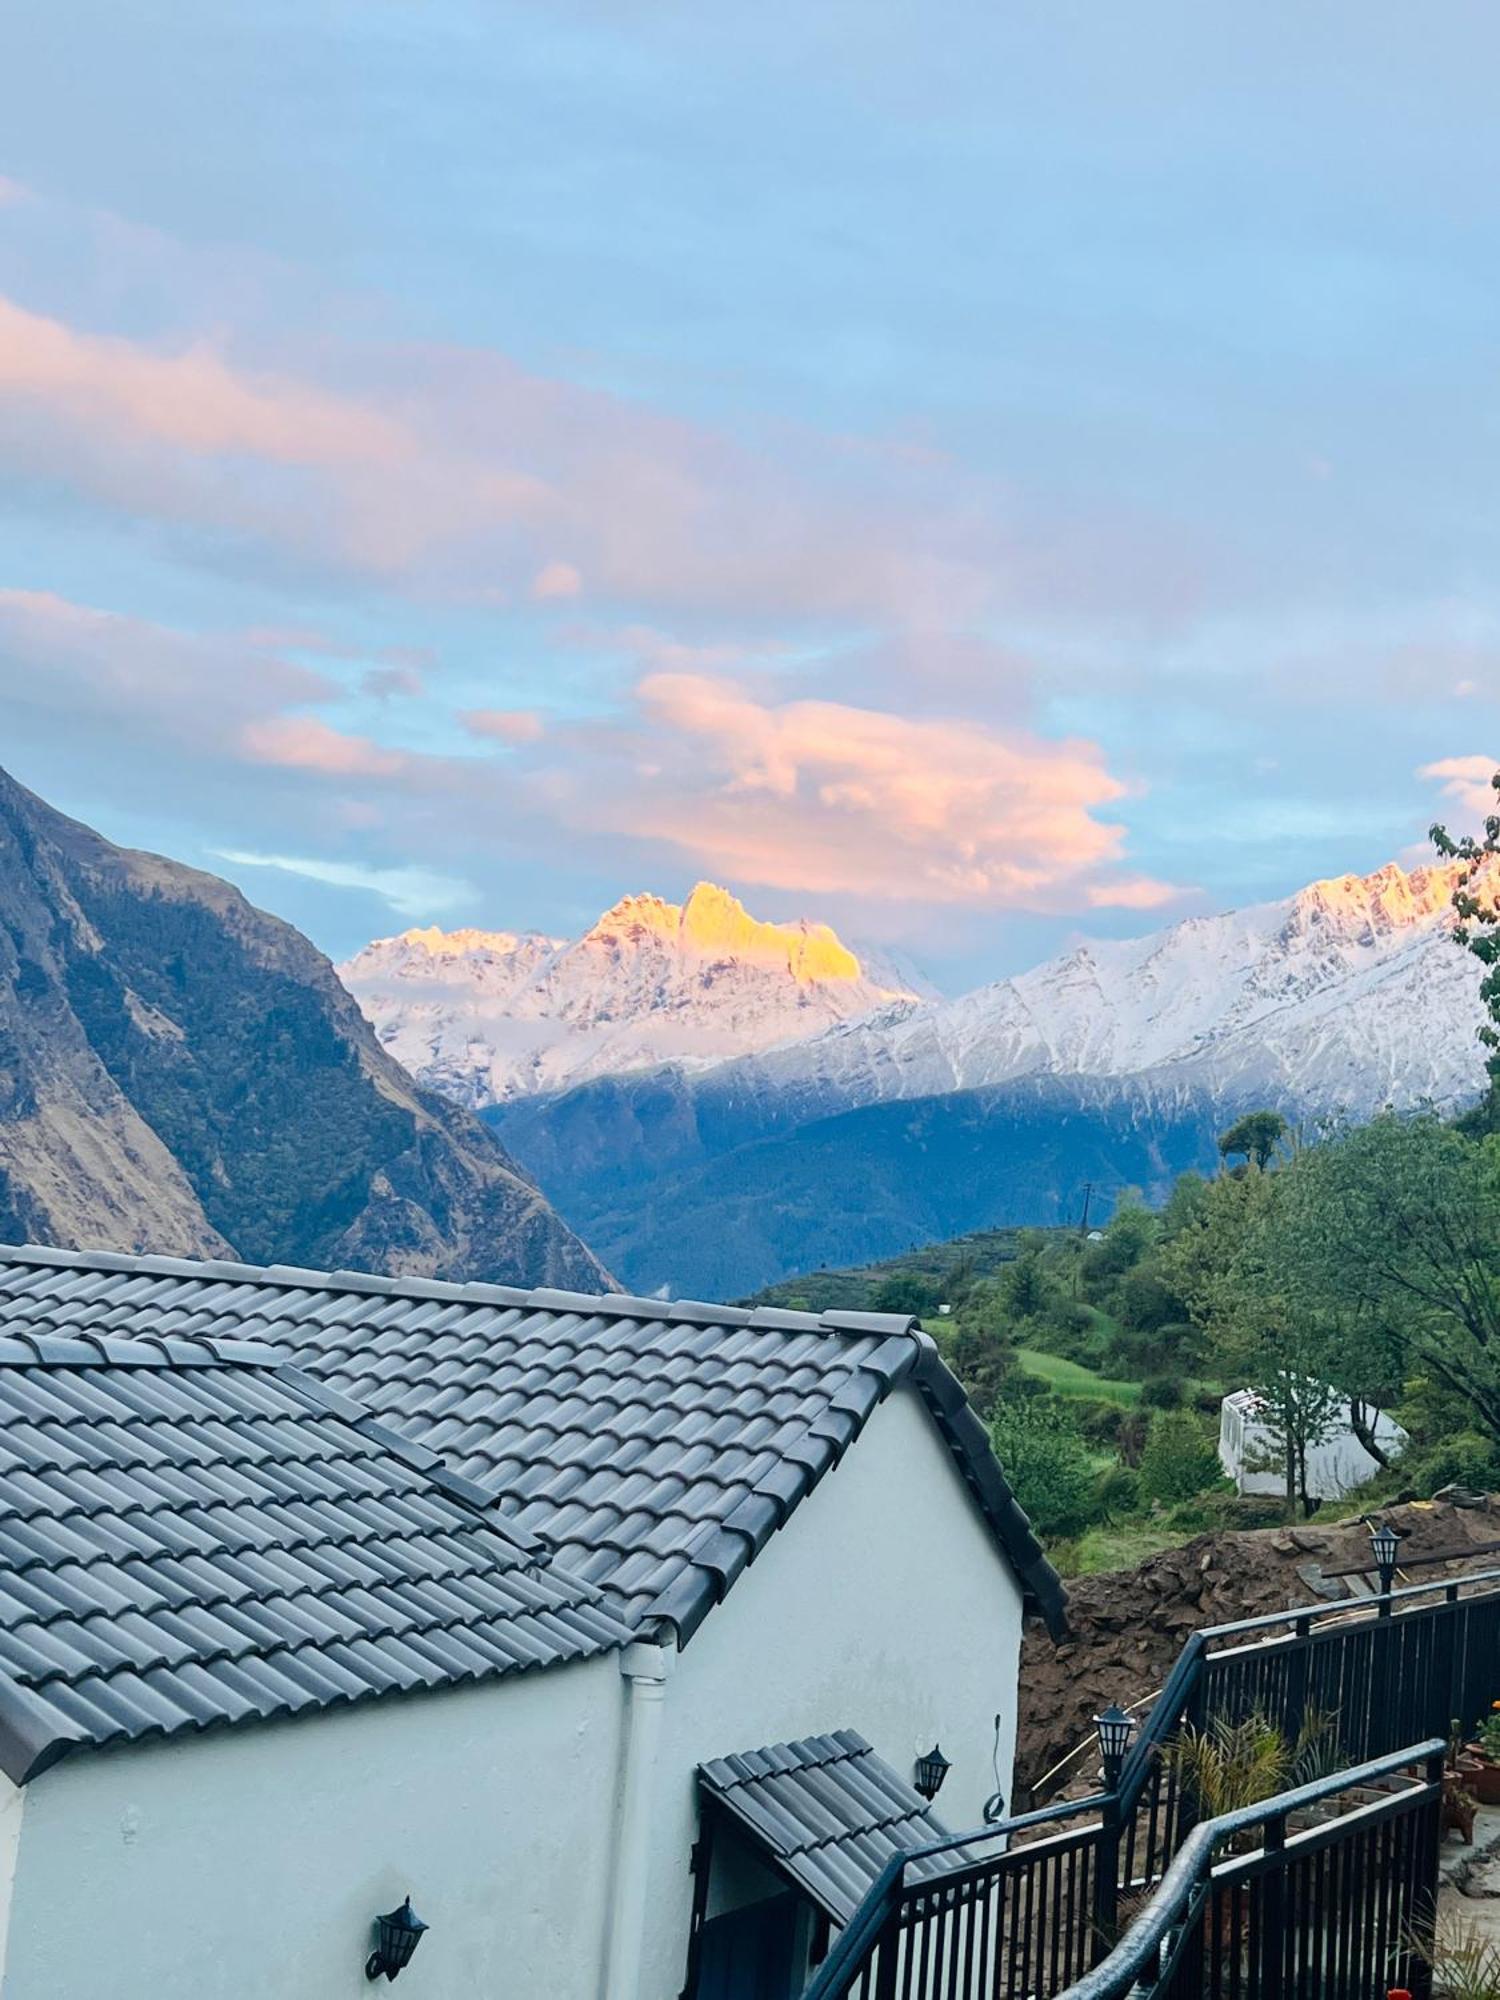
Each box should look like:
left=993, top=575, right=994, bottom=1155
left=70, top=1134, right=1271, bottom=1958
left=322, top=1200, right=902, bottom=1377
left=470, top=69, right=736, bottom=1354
left=0, top=772, right=604, bottom=1290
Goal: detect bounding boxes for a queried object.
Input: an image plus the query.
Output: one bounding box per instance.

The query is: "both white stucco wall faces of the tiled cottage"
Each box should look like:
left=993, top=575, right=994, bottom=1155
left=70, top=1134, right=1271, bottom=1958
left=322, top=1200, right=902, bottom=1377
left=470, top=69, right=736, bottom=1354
left=0, top=1390, right=1022, bottom=2000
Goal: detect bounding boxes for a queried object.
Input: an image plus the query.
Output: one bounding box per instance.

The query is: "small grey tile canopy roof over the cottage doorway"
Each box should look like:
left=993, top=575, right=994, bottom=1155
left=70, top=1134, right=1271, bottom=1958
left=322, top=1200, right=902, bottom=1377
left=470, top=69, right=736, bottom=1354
left=698, top=1730, right=952, bottom=1926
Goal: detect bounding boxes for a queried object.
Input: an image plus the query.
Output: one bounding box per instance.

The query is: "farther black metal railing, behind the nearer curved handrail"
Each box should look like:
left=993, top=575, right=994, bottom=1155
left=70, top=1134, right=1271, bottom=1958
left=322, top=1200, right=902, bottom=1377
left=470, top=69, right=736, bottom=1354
left=804, top=1570, right=1500, bottom=2000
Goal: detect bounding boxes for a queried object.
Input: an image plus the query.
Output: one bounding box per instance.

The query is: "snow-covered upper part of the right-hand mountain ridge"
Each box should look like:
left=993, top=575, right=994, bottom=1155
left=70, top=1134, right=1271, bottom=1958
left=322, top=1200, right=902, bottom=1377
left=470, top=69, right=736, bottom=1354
left=736, top=862, right=1484, bottom=1118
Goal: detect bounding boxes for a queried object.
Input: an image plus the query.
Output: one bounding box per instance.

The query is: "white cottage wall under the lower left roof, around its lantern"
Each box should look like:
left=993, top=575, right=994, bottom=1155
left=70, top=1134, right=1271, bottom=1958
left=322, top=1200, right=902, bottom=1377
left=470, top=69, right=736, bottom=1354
left=0, top=1656, right=620, bottom=2000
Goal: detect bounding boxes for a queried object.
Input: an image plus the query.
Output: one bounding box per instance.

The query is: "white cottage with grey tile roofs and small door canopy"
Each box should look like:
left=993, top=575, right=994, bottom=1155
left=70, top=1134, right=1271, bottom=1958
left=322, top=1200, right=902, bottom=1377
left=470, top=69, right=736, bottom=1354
left=0, top=1248, right=1062, bottom=2000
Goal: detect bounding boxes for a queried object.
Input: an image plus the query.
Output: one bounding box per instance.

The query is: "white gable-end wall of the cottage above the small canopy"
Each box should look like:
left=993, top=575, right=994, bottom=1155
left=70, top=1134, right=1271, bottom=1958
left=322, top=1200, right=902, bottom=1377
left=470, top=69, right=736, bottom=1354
left=636, top=1390, right=1022, bottom=2000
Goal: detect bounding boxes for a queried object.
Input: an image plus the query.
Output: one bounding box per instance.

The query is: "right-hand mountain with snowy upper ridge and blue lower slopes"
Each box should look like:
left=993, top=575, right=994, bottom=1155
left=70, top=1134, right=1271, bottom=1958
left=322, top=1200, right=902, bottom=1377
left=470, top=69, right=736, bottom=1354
left=486, top=866, right=1484, bottom=1294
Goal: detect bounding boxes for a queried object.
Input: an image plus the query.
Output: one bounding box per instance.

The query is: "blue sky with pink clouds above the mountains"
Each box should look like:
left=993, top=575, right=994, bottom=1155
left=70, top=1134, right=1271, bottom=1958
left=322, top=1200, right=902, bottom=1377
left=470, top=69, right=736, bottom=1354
left=0, top=0, right=1500, bottom=990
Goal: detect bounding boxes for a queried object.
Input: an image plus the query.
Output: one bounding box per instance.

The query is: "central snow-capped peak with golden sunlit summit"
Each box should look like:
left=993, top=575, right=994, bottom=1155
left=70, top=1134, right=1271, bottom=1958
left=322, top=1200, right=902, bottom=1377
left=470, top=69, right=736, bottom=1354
left=340, top=882, right=930, bottom=1106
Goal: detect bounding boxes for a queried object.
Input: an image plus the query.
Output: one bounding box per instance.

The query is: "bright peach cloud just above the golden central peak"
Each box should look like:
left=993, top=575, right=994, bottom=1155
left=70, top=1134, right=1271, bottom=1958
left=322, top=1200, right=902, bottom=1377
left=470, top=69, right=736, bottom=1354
left=554, top=672, right=1178, bottom=910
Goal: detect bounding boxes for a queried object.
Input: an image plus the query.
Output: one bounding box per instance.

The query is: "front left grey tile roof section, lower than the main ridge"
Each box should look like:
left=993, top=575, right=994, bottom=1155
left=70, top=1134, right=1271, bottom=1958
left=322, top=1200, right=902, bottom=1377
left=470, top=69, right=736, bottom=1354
left=0, top=1312, right=630, bottom=1784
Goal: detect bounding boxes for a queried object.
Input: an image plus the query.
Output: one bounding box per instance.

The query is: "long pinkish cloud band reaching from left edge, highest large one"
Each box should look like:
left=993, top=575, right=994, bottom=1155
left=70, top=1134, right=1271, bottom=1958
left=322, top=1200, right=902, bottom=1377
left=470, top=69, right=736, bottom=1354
left=0, top=282, right=1152, bottom=630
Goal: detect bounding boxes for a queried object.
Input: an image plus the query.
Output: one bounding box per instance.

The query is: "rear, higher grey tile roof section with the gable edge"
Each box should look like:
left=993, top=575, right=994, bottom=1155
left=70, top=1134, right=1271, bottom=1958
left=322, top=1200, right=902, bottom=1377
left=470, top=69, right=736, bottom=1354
left=0, top=1248, right=1064, bottom=1642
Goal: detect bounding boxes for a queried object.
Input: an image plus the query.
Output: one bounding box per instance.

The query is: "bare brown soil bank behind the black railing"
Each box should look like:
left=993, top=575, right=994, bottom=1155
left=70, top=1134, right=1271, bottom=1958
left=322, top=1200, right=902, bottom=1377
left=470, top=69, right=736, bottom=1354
left=1014, top=1496, right=1500, bottom=1810
